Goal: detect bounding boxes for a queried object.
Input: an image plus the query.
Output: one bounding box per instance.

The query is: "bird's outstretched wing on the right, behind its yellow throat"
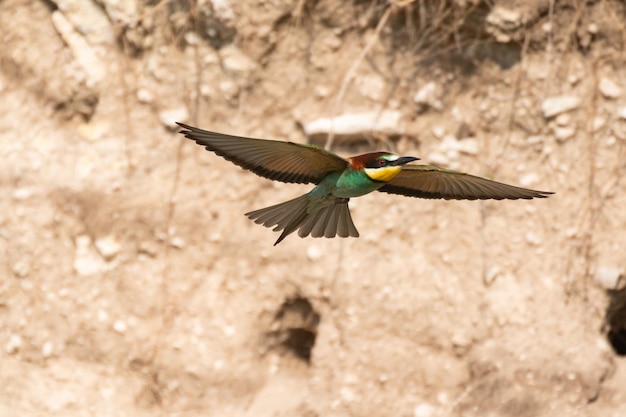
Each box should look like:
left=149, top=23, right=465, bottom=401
left=378, top=165, right=554, bottom=200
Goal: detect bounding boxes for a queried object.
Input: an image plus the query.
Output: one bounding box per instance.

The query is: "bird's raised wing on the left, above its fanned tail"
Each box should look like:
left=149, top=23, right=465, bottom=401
left=177, top=123, right=349, bottom=184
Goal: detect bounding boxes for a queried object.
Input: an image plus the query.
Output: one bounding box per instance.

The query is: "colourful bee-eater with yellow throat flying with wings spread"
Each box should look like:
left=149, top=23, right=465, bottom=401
left=178, top=123, right=553, bottom=245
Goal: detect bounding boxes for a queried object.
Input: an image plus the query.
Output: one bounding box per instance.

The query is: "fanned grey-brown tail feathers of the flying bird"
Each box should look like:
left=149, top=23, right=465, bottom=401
left=246, top=194, right=359, bottom=245
